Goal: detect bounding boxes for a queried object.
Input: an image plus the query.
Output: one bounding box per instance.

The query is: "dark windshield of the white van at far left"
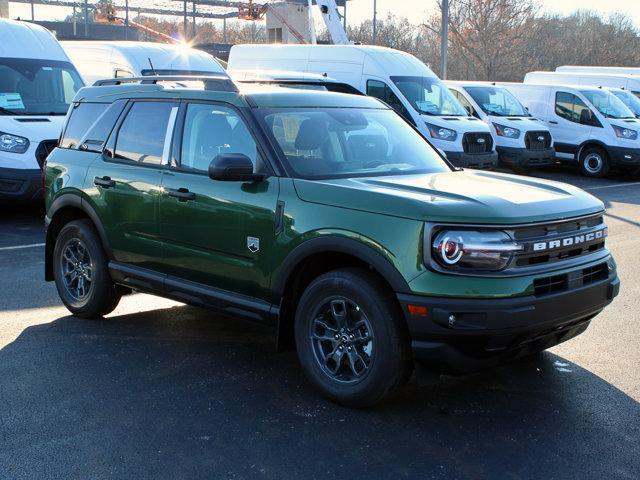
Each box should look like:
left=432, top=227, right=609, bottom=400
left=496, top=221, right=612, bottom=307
left=0, top=58, right=84, bottom=115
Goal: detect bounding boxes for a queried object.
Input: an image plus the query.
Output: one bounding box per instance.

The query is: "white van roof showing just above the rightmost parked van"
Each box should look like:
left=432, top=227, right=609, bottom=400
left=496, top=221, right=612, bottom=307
left=524, top=72, right=640, bottom=98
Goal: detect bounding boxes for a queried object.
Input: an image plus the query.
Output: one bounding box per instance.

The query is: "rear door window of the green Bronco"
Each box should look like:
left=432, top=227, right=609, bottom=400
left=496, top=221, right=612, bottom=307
left=115, top=102, right=178, bottom=165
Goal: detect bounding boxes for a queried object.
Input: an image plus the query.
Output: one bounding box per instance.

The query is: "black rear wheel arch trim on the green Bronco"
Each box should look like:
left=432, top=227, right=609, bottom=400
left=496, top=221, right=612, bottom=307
left=44, top=193, right=112, bottom=281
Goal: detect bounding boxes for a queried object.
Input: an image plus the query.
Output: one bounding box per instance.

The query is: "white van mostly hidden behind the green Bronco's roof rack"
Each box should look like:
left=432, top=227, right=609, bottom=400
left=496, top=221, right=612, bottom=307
left=60, top=41, right=225, bottom=85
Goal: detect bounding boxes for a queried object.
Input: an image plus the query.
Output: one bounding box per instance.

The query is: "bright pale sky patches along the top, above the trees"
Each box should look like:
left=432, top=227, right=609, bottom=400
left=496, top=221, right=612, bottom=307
left=9, top=0, right=640, bottom=28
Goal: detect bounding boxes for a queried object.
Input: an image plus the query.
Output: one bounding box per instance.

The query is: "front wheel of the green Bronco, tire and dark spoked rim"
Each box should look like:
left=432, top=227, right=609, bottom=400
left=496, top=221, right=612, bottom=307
left=295, top=268, right=413, bottom=408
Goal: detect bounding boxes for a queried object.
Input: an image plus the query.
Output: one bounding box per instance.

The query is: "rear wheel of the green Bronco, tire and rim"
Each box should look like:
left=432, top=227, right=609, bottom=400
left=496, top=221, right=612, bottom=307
left=53, top=220, right=121, bottom=318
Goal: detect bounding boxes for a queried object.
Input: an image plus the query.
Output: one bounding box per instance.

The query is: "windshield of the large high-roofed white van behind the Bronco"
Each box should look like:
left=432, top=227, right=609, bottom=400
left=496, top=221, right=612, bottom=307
left=391, top=77, right=469, bottom=117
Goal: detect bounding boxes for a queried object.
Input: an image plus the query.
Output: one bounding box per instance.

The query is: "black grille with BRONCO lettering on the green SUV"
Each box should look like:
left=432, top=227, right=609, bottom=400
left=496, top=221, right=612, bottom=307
left=510, top=215, right=607, bottom=268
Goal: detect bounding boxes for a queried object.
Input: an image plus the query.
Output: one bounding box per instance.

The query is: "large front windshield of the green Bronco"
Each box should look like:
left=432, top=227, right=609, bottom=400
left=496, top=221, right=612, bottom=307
left=259, top=108, right=450, bottom=178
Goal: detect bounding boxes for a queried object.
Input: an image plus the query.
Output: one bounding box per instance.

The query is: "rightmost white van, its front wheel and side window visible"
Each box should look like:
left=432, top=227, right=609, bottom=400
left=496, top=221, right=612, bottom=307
left=500, top=83, right=640, bottom=177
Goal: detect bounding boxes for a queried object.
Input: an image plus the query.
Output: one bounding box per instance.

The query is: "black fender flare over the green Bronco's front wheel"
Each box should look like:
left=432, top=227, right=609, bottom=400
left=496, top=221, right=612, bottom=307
left=272, top=235, right=411, bottom=298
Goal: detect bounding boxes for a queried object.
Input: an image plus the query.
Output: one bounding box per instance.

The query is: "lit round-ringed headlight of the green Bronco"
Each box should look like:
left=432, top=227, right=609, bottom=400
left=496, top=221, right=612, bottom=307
left=431, top=230, right=523, bottom=271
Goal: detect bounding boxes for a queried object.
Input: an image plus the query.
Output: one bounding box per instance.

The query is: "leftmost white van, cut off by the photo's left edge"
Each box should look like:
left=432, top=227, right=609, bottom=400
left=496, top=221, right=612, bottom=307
left=0, top=19, right=84, bottom=202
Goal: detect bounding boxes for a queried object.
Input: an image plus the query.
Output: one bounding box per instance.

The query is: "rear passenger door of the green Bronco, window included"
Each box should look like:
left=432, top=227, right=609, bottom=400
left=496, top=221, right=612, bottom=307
left=86, top=100, right=178, bottom=271
